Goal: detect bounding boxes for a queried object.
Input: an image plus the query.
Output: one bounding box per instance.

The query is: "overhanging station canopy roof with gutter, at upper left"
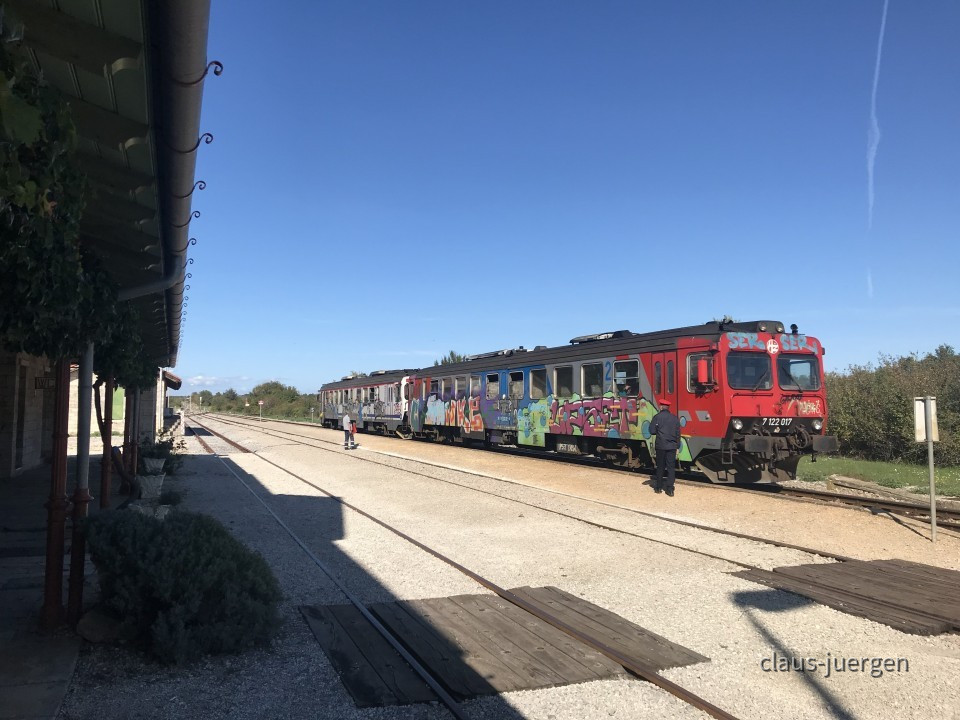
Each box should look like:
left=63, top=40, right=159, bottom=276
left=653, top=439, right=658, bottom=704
left=2, top=0, right=210, bottom=366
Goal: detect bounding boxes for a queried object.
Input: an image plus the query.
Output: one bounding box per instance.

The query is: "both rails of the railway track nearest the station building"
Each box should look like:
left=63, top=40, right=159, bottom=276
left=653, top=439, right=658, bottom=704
left=191, top=418, right=751, bottom=720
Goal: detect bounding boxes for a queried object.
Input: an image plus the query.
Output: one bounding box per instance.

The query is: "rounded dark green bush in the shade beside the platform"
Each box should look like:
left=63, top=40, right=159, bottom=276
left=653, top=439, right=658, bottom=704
left=85, top=510, right=281, bottom=663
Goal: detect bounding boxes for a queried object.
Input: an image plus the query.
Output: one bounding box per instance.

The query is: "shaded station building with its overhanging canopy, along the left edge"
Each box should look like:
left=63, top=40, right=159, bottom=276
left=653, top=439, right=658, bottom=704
left=0, top=0, right=216, bottom=626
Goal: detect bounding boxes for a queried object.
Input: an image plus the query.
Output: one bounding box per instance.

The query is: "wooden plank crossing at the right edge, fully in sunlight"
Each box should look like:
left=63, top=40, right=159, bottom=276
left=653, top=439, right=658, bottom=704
left=733, top=560, right=960, bottom=635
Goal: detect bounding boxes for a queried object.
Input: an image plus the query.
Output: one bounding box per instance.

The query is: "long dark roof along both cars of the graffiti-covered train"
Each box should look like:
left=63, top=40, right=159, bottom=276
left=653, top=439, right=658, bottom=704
left=321, top=319, right=784, bottom=390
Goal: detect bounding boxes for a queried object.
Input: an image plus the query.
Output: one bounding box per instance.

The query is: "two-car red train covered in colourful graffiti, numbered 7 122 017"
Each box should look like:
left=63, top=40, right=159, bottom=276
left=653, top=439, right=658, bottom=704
left=320, top=320, right=837, bottom=483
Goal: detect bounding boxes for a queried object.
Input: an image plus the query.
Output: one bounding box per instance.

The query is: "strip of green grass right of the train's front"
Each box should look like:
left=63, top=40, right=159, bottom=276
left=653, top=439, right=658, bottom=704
left=797, top=455, right=960, bottom=496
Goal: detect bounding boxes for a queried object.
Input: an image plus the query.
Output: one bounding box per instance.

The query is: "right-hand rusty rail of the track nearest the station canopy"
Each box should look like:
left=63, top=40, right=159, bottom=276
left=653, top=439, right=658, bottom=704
left=193, top=420, right=737, bottom=720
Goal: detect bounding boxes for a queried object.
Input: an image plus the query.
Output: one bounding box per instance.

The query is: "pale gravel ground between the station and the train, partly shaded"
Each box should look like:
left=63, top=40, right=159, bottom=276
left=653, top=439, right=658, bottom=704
left=61, top=416, right=960, bottom=720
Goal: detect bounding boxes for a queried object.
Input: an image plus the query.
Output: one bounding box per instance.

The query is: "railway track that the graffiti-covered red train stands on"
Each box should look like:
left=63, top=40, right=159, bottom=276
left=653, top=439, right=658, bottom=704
left=201, top=415, right=960, bottom=533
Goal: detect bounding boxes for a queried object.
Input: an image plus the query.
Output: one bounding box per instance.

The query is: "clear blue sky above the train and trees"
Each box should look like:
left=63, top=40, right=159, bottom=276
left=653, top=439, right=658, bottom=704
left=175, top=0, right=960, bottom=392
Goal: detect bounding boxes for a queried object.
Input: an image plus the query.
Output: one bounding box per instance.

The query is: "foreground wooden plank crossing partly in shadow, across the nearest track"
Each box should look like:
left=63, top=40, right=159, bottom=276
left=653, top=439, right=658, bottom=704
left=301, top=587, right=707, bottom=707
